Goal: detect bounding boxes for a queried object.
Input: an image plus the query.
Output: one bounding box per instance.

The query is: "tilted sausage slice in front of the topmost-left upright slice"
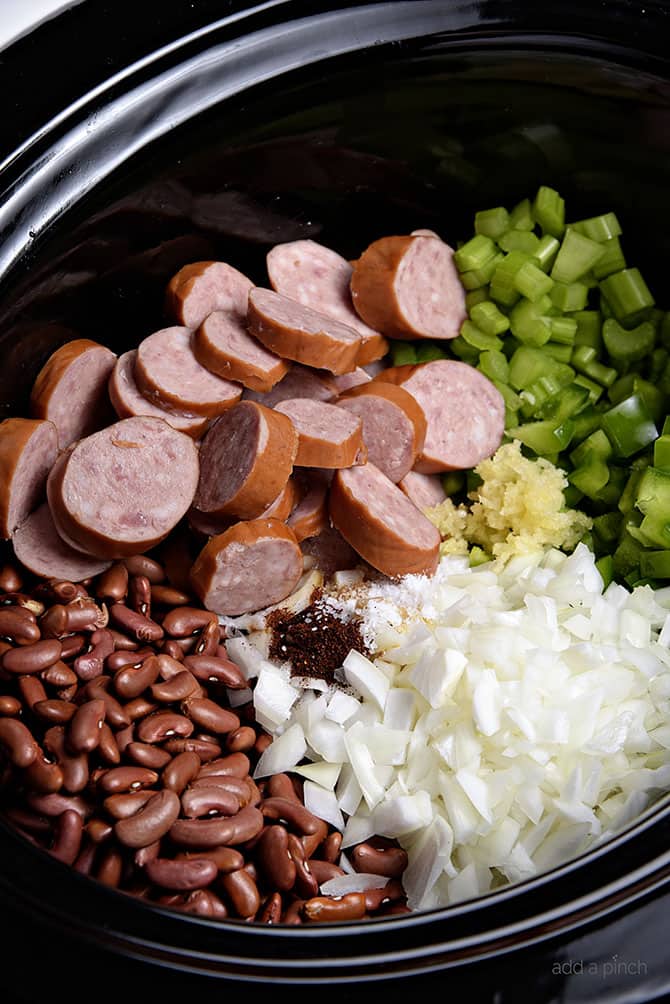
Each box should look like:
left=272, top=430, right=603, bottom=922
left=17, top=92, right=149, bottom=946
left=193, top=310, right=288, bottom=393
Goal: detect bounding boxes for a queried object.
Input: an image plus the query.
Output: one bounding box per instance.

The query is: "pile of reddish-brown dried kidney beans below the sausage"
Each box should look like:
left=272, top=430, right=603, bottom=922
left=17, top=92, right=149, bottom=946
left=0, top=555, right=408, bottom=925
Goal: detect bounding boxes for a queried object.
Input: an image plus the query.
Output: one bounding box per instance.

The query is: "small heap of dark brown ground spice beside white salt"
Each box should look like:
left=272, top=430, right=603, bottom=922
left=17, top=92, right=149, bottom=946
left=267, top=598, right=368, bottom=683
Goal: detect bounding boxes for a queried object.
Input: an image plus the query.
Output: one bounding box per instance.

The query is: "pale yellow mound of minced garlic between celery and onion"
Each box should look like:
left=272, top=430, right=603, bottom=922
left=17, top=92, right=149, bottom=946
left=426, top=441, right=592, bottom=562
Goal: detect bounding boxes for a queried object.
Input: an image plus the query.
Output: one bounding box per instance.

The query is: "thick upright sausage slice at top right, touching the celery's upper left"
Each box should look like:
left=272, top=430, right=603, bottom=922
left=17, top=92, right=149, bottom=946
left=352, top=235, right=467, bottom=338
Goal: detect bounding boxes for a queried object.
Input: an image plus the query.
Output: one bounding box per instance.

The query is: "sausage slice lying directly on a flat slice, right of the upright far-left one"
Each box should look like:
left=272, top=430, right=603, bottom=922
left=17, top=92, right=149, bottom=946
left=135, top=327, right=242, bottom=418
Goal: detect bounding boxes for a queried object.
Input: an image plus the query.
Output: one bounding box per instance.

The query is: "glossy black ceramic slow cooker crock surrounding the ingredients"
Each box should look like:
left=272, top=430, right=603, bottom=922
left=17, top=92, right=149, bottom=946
left=0, top=0, right=670, bottom=1004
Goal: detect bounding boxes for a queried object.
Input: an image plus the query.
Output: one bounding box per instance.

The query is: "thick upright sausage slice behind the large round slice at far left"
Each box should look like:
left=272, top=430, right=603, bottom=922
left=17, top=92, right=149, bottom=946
left=30, top=338, right=117, bottom=450
